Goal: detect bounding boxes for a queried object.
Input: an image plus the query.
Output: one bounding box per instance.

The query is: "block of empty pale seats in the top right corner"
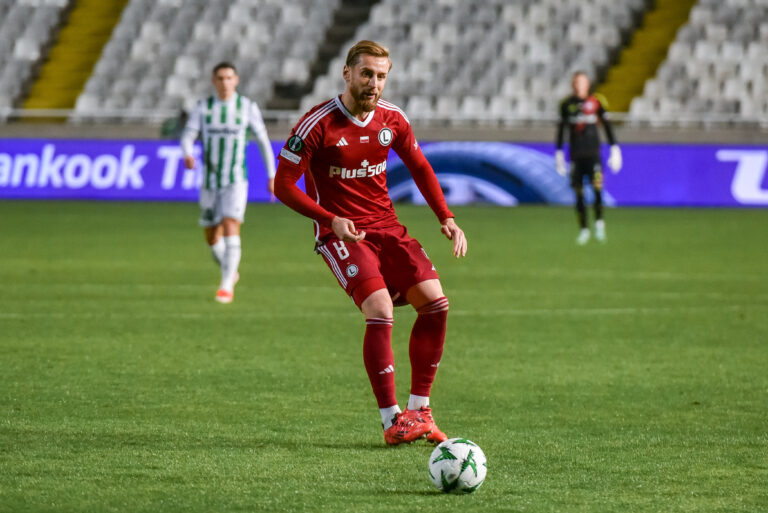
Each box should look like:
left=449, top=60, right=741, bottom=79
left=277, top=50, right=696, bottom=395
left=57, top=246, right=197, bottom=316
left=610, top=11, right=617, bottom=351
left=630, top=0, right=768, bottom=124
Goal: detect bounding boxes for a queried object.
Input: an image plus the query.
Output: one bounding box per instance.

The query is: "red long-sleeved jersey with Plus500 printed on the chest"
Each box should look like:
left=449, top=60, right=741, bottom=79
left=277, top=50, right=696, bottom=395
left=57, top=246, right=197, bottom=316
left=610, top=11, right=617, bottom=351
left=275, top=97, right=453, bottom=241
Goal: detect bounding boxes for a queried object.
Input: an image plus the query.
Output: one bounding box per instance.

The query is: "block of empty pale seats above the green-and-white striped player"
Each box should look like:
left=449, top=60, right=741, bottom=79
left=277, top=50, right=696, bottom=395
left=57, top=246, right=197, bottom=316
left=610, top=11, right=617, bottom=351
left=73, top=0, right=339, bottom=120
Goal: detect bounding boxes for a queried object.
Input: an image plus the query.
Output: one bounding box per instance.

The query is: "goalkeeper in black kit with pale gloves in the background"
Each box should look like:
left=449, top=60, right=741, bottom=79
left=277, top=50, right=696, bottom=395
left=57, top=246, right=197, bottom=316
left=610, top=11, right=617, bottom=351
left=555, top=71, right=621, bottom=245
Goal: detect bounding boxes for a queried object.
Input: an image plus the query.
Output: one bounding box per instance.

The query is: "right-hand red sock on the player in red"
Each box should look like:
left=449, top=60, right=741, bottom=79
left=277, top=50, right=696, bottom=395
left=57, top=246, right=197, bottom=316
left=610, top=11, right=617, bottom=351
left=408, top=297, right=448, bottom=397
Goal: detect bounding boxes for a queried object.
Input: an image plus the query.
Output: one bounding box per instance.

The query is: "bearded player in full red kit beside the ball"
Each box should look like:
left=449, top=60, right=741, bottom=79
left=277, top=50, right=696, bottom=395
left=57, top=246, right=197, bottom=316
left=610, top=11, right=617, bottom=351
left=275, top=41, right=467, bottom=445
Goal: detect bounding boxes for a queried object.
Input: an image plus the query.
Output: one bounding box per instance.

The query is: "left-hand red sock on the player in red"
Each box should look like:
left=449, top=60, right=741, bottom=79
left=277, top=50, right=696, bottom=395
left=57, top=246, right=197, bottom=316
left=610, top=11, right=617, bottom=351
left=363, top=318, right=397, bottom=408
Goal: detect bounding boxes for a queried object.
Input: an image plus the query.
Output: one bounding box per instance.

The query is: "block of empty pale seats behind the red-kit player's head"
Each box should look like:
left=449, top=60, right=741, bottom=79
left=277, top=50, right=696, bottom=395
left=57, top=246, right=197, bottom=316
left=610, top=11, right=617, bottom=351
left=302, top=0, right=648, bottom=122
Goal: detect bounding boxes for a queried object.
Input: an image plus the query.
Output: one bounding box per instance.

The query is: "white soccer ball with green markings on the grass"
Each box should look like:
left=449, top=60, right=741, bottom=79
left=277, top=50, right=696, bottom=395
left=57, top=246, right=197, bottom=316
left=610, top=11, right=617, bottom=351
left=429, top=438, right=487, bottom=493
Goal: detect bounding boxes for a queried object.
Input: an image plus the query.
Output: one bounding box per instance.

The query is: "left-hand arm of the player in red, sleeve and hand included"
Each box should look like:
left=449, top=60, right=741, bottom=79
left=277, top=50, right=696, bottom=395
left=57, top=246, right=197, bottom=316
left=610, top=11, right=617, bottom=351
left=275, top=133, right=365, bottom=242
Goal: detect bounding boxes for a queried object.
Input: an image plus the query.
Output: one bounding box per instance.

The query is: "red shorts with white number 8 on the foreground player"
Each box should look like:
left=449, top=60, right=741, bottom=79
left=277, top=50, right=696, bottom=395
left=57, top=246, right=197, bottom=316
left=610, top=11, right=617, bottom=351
left=317, top=225, right=439, bottom=306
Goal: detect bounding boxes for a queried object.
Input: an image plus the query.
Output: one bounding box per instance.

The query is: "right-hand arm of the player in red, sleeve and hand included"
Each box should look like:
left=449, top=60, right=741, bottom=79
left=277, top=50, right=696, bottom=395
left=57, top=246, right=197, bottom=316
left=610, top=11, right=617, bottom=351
left=393, top=123, right=467, bottom=258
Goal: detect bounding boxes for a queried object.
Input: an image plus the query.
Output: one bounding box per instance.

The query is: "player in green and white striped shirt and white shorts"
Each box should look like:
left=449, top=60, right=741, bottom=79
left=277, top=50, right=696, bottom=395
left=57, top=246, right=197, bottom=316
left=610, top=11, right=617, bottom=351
left=181, top=62, right=275, bottom=303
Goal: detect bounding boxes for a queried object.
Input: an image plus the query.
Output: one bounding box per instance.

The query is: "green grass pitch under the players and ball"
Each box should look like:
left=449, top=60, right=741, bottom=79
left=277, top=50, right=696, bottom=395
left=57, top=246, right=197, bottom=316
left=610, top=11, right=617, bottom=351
left=0, top=201, right=768, bottom=513
